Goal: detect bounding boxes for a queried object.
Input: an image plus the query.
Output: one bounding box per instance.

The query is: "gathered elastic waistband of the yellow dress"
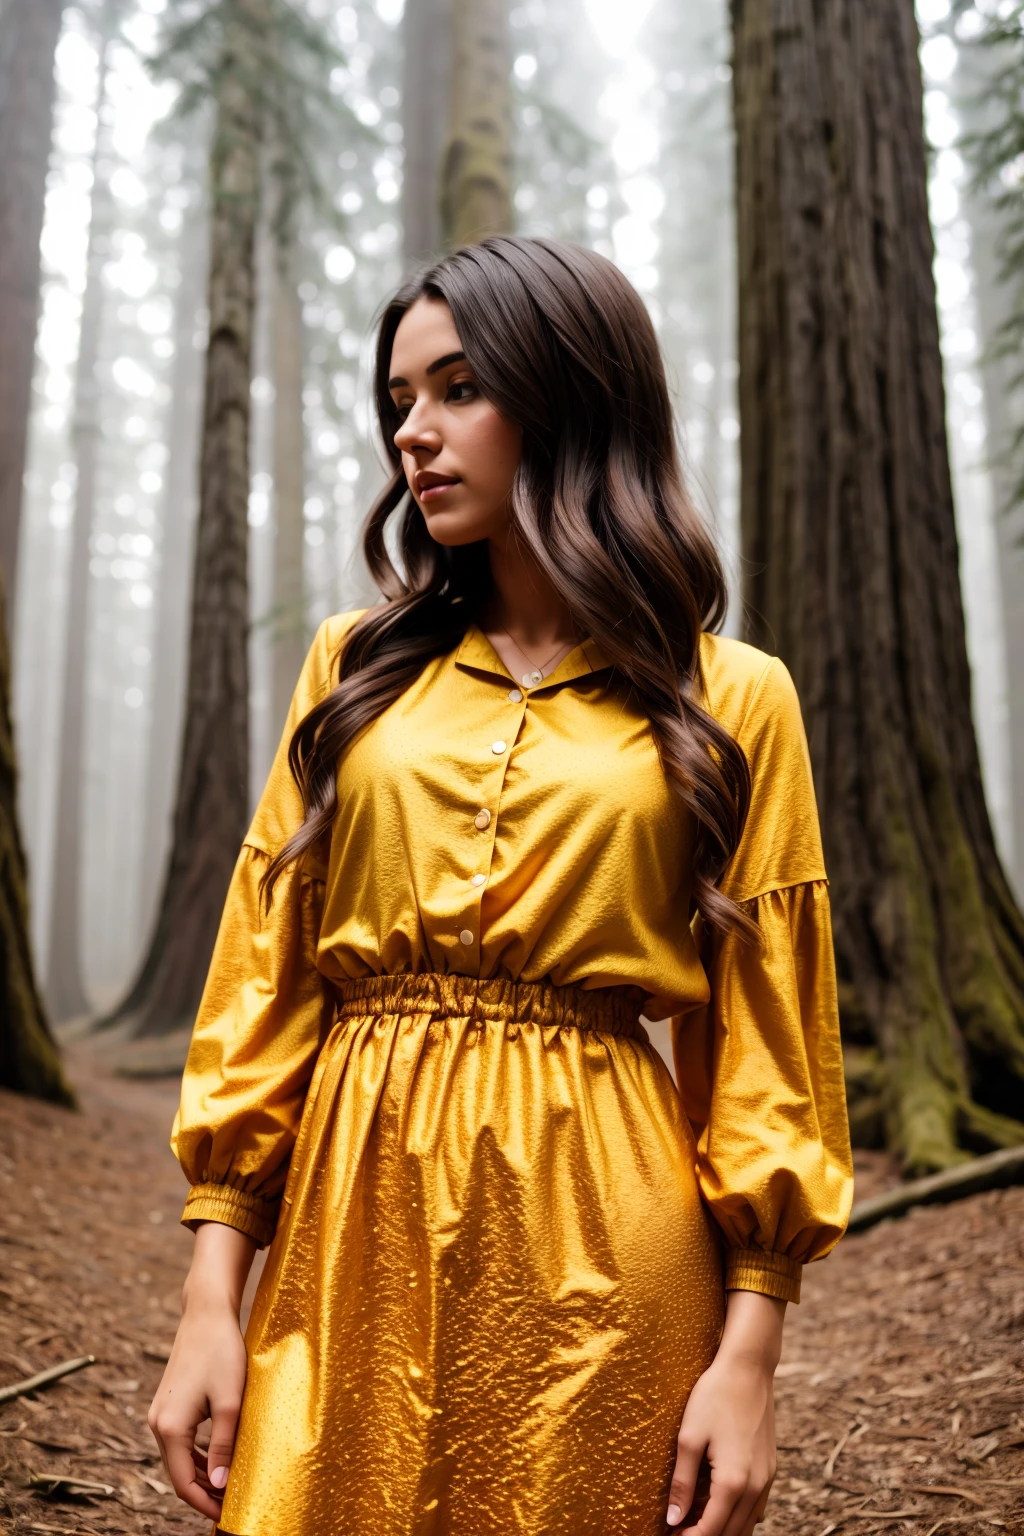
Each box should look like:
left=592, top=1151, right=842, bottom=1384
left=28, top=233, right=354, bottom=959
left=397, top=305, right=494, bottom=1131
left=336, top=972, right=646, bottom=1038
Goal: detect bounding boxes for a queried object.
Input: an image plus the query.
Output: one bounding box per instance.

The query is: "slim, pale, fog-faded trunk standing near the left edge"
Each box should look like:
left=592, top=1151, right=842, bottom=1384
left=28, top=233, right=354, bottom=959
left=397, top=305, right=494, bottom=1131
left=46, top=12, right=115, bottom=1023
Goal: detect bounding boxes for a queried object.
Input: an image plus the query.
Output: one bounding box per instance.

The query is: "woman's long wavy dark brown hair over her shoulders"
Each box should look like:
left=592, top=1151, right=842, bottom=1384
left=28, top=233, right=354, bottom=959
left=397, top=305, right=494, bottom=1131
left=263, top=237, right=754, bottom=934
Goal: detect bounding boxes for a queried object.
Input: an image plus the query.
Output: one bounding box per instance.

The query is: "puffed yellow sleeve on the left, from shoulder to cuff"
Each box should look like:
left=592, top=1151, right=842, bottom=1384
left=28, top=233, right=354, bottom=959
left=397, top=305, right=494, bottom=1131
left=170, top=619, right=359, bottom=1247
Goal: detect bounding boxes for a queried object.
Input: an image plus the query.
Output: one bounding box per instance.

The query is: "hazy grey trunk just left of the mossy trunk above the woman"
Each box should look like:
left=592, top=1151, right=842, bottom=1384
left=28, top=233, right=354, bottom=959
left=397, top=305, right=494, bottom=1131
left=402, top=0, right=453, bottom=270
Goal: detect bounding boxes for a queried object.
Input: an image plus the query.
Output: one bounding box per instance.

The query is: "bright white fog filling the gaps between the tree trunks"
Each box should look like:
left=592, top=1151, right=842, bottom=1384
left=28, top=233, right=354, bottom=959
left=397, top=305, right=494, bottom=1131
left=12, top=0, right=1024, bottom=1008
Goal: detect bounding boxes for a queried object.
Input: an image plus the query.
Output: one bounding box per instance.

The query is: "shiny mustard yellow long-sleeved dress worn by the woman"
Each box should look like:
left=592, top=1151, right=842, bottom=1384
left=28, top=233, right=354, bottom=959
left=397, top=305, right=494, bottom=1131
left=173, top=614, right=852, bottom=1536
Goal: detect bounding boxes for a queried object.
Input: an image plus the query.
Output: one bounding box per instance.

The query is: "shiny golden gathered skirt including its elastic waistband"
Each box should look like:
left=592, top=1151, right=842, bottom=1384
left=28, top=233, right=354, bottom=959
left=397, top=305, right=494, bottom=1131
left=221, top=975, right=723, bottom=1536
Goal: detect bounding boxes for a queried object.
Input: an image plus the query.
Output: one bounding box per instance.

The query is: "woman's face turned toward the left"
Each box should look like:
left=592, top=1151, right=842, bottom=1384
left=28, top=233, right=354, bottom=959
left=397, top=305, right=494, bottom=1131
left=388, top=298, right=522, bottom=545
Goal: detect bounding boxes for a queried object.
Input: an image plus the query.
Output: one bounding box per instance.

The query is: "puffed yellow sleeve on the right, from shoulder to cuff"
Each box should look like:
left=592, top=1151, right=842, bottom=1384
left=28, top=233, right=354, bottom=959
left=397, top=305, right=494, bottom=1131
left=672, top=642, right=852, bottom=1301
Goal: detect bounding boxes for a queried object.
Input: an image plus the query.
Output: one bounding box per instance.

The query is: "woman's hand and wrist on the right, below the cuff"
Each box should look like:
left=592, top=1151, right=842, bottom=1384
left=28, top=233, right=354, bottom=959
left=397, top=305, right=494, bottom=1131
left=666, top=1290, right=786, bottom=1536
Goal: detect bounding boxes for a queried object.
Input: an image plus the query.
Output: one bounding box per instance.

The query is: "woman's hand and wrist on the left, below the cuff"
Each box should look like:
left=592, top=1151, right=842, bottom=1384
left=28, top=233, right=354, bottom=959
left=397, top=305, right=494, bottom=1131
left=149, top=1221, right=256, bottom=1521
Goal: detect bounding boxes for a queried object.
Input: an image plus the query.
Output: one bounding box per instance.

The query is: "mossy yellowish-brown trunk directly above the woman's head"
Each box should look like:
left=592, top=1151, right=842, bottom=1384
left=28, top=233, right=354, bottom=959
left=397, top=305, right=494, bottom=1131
left=441, top=0, right=513, bottom=246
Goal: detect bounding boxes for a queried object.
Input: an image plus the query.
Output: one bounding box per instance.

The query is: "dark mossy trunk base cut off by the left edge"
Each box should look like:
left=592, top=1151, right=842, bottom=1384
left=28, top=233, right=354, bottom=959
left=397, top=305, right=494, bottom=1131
left=0, top=573, right=75, bottom=1104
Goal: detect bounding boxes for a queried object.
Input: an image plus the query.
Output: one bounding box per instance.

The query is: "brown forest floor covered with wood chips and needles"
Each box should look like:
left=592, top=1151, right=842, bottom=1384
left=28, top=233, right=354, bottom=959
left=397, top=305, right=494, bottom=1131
left=0, top=1048, right=1024, bottom=1536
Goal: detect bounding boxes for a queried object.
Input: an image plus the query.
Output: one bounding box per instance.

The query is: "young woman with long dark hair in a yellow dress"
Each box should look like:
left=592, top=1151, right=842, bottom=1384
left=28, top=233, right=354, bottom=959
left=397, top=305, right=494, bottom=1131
left=150, top=238, right=851, bottom=1536
